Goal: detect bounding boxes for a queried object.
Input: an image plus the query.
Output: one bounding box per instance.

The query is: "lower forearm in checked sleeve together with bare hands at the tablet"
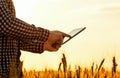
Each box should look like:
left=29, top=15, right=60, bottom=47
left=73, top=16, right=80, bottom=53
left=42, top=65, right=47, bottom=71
left=20, top=31, right=71, bottom=53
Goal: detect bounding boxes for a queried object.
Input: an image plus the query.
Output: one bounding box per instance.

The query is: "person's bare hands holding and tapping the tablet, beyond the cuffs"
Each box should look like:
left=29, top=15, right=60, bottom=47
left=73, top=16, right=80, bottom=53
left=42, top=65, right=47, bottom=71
left=44, top=31, right=71, bottom=51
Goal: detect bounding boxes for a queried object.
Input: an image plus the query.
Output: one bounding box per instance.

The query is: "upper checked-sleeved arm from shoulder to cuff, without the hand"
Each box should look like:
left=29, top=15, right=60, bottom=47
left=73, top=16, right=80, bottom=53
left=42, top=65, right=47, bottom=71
left=0, top=0, right=49, bottom=43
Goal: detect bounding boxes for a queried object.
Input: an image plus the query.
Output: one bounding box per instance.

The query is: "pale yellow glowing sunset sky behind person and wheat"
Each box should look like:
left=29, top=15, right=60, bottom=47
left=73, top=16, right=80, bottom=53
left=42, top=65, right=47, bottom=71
left=14, top=0, right=120, bottom=70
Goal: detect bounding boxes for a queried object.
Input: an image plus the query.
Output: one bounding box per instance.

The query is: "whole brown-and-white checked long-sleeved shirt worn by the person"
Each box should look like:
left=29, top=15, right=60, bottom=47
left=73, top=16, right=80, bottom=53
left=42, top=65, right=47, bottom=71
left=0, top=0, right=49, bottom=78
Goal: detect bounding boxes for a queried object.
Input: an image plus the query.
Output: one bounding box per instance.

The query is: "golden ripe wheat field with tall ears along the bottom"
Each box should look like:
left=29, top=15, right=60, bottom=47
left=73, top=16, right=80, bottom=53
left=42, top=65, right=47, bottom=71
left=0, top=54, right=120, bottom=78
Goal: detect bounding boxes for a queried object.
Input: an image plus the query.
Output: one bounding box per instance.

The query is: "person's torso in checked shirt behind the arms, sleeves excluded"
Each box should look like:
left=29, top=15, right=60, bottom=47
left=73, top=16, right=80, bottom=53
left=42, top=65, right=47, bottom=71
left=0, top=0, right=20, bottom=75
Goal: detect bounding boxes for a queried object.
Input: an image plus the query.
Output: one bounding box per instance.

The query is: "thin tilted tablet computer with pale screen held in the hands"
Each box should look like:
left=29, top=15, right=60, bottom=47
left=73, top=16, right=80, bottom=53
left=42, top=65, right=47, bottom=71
left=63, top=27, right=86, bottom=44
